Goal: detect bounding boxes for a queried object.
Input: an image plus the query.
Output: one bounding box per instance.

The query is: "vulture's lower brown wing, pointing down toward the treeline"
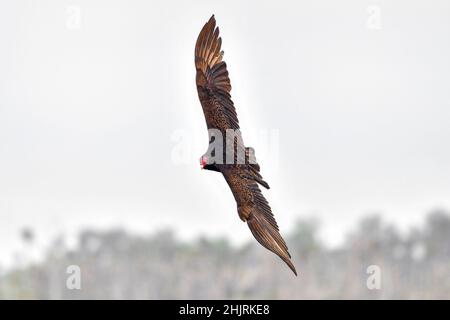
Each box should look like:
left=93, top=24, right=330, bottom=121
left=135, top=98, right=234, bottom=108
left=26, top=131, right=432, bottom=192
left=222, top=167, right=297, bottom=275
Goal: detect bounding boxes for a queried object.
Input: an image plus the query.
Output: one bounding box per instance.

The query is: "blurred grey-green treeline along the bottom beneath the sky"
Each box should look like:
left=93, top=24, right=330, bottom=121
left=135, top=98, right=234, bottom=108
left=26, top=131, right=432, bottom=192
left=0, top=210, right=450, bottom=299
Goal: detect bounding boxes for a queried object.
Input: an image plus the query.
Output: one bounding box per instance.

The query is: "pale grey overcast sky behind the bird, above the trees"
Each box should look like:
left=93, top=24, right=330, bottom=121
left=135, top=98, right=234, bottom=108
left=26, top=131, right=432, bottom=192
left=0, top=0, right=450, bottom=265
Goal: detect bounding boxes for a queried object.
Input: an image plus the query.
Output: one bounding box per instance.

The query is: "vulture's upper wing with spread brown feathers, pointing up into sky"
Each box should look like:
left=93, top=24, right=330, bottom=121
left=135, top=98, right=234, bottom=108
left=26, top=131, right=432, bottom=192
left=195, top=15, right=239, bottom=132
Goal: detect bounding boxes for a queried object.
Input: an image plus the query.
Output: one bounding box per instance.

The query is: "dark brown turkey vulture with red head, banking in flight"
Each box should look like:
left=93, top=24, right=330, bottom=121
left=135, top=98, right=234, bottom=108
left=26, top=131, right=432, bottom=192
left=195, top=15, right=297, bottom=275
